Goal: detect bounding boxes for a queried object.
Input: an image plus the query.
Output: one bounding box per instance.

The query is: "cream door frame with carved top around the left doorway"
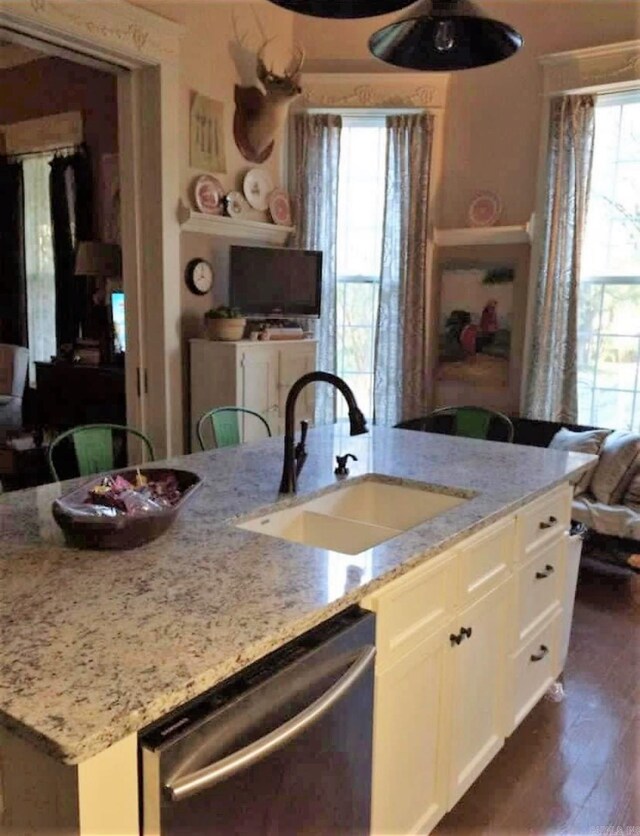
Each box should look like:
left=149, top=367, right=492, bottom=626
left=0, top=0, right=184, bottom=458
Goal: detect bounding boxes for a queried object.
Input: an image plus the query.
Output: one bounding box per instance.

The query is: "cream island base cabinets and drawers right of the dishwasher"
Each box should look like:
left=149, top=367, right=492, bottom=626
left=362, top=485, right=575, bottom=836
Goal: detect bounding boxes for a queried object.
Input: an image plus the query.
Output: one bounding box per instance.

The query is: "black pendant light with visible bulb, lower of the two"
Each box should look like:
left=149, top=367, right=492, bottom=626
left=369, top=0, right=524, bottom=72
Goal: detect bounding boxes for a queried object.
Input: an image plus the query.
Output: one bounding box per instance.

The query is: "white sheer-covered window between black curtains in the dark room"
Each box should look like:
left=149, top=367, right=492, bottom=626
left=23, top=154, right=57, bottom=383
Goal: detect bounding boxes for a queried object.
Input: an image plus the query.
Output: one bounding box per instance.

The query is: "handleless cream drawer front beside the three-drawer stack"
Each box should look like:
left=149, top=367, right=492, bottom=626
left=458, top=517, right=516, bottom=606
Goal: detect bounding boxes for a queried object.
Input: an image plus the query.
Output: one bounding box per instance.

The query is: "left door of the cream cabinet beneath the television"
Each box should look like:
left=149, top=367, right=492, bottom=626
left=240, top=346, right=278, bottom=442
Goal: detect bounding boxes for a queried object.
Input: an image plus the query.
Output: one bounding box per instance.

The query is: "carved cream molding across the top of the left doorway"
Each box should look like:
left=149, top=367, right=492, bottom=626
left=0, top=0, right=183, bottom=64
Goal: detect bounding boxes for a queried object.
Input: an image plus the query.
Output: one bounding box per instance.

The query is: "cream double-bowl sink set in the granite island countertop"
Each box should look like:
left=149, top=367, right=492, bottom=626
left=238, top=477, right=471, bottom=554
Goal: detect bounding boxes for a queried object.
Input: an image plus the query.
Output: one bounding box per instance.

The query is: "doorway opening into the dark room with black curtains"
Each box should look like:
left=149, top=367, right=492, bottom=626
left=0, top=29, right=127, bottom=444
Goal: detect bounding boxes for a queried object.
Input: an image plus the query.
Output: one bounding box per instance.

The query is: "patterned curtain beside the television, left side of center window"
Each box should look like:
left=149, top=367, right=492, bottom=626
left=293, top=113, right=342, bottom=424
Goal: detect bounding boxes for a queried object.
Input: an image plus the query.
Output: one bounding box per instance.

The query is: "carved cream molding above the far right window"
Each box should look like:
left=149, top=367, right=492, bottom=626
left=539, top=40, right=640, bottom=96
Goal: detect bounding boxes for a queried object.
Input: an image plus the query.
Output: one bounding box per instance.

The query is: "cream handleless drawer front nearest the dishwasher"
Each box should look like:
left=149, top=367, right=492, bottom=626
left=362, top=552, right=457, bottom=672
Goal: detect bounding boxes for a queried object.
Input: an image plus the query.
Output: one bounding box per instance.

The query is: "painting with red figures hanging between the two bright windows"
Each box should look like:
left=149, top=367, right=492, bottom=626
left=436, top=265, right=515, bottom=387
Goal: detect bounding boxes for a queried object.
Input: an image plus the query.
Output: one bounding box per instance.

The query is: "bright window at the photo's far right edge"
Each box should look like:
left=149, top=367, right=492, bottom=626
left=578, top=91, right=640, bottom=431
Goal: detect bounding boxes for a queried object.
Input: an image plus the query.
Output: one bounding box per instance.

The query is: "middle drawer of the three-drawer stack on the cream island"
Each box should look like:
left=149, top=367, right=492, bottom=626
left=517, top=534, right=567, bottom=642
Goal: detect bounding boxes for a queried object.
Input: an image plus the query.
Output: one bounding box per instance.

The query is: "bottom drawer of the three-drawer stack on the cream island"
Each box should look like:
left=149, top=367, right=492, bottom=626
left=509, top=608, right=562, bottom=731
